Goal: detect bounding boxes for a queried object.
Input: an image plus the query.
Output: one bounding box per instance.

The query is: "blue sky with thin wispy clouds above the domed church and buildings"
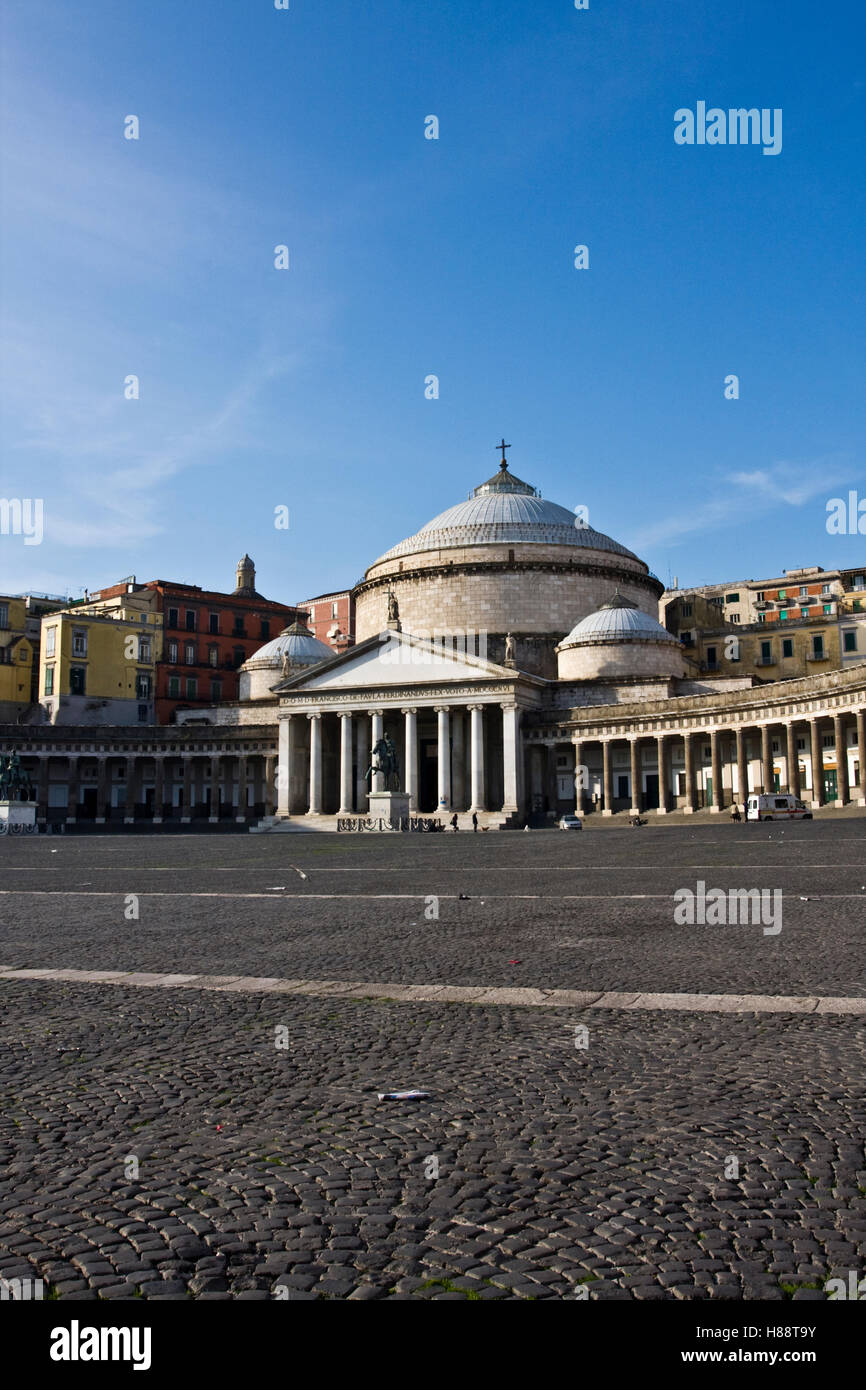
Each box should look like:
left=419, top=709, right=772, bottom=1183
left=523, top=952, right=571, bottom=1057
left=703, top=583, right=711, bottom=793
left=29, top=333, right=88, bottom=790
left=0, top=0, right=866, bottom=600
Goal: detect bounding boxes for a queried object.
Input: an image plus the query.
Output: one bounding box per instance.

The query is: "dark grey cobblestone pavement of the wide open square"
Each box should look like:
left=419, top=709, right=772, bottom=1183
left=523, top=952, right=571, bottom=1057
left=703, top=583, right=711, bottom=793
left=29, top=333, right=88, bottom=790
left=0, top=821, right=866, bottom=1300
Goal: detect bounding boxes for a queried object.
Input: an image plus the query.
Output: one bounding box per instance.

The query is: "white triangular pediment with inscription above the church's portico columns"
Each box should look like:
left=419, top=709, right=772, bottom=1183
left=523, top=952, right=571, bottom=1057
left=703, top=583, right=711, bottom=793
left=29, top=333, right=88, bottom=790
left=274, top=628, right=518, bottom=695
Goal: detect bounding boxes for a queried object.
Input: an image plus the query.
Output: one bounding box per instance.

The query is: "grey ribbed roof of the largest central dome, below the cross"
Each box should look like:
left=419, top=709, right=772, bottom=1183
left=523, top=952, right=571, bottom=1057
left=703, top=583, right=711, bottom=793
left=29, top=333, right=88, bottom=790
left=377, top=464, right=637, bottom=564
